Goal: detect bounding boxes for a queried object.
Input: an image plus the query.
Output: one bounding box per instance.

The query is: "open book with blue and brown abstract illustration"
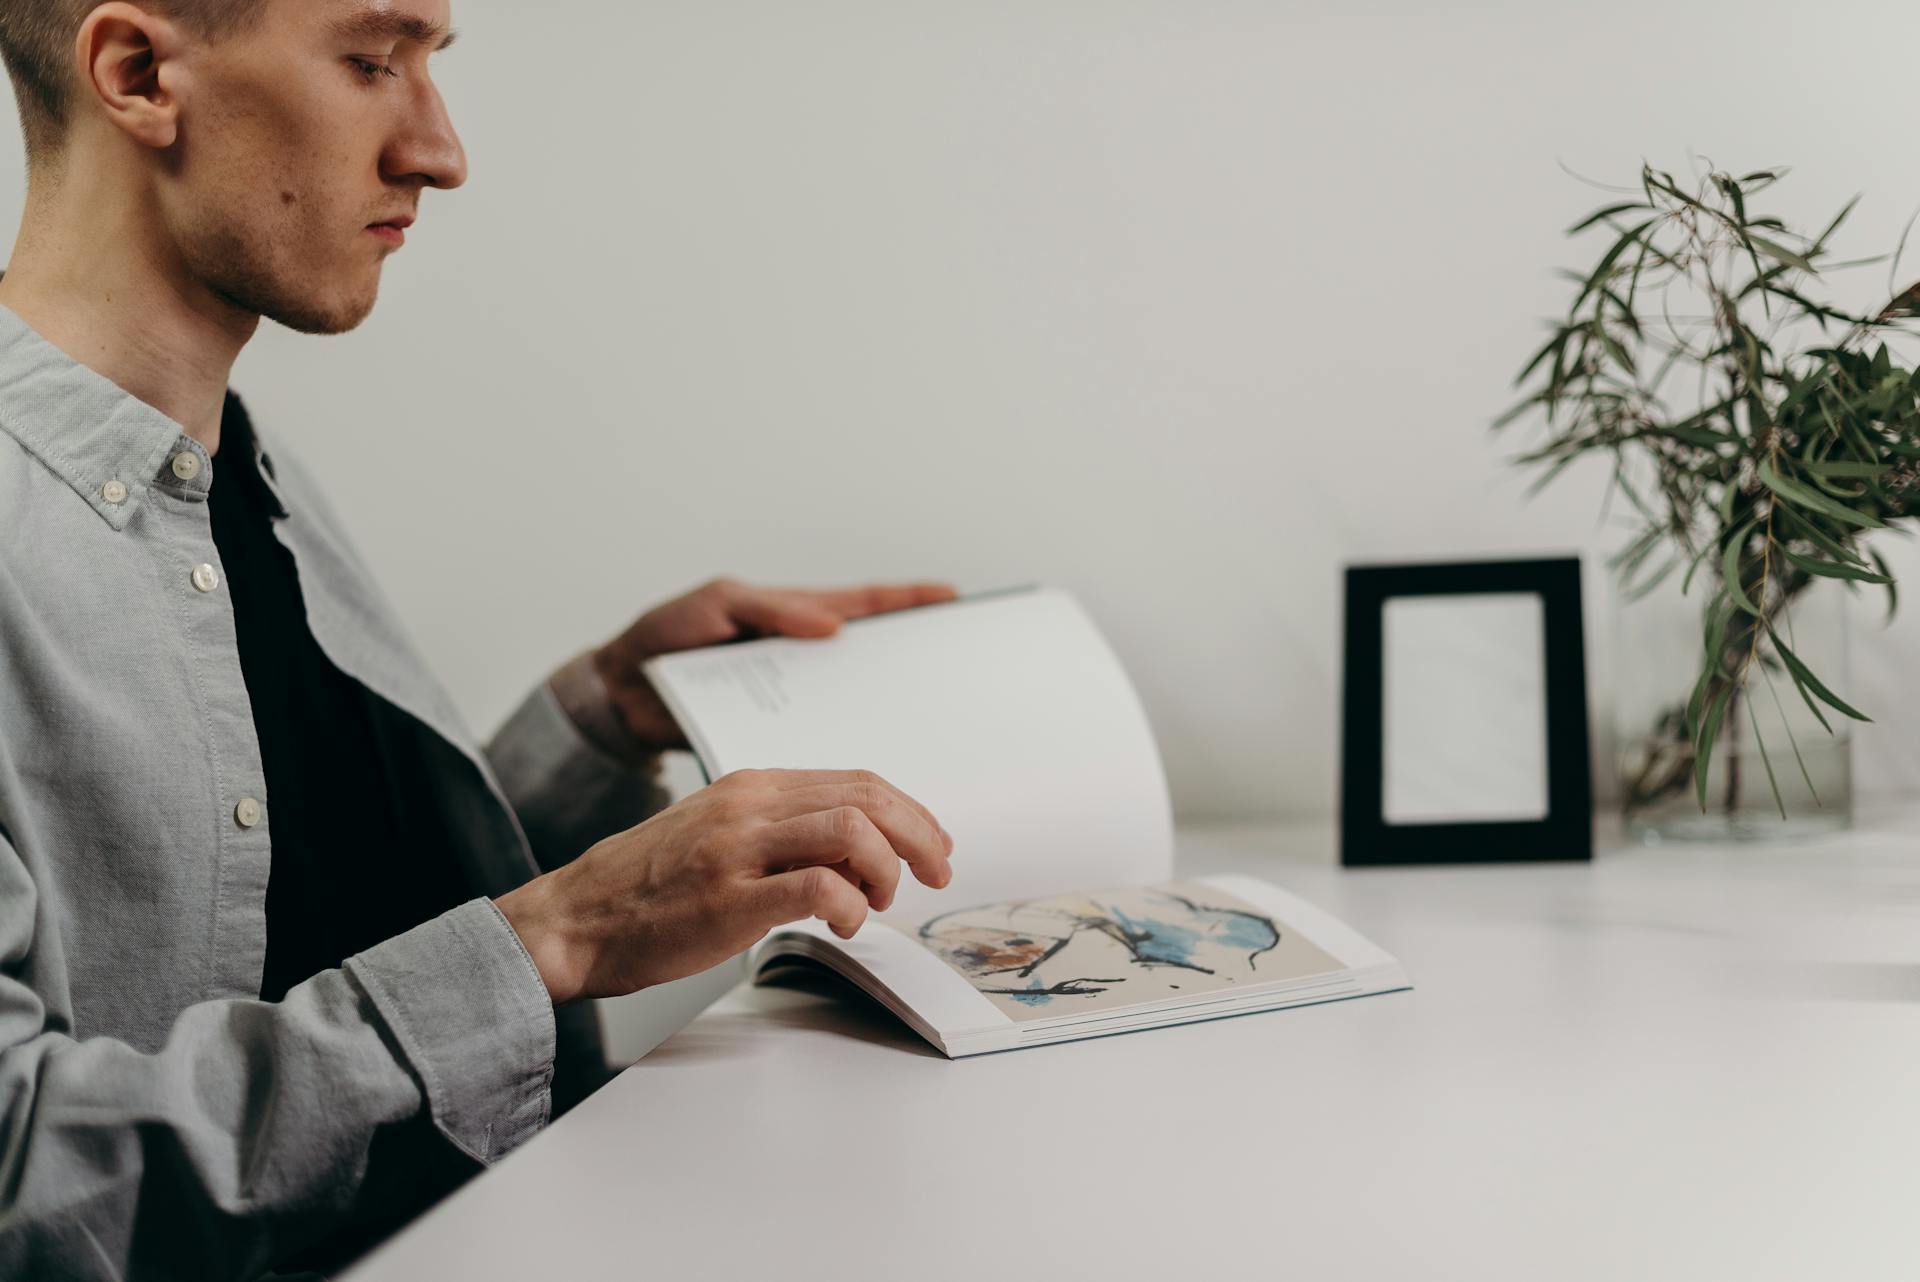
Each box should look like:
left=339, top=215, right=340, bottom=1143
left=645, top=587, right=1407, bottom=1056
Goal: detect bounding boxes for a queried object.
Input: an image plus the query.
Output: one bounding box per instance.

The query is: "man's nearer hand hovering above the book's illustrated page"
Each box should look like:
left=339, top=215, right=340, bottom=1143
left=495, top=770, right=952, bottom=1006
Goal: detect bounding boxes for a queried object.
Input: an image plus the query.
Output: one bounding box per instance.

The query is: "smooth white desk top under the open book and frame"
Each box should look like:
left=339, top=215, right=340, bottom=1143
left=351, top=808, right=1920, bottom=1282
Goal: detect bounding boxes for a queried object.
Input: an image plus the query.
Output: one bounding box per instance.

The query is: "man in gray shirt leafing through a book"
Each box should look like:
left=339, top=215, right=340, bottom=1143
left=0, top=0, right=952, bottom=1278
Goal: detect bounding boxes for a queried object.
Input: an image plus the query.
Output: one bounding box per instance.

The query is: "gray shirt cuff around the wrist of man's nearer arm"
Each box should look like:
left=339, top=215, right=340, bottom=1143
left=346, top=898, right=555, bottom=1163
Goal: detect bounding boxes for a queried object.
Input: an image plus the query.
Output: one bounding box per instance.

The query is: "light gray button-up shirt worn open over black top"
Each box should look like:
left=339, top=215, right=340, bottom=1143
left=0, top=307, right=666, bottom=1278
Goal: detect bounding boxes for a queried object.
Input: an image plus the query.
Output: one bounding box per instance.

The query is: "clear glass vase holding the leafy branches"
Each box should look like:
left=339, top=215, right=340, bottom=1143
left=1613, top=570, right=1853, bottom=844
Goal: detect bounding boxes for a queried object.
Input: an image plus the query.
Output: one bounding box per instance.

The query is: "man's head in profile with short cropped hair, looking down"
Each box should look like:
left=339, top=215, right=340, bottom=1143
left=0, top=0, right=467, bottom=334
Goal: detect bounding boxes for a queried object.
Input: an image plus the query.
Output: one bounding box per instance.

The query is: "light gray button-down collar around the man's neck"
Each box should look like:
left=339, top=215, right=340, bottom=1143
left=0, top=305, right=286, bottom=530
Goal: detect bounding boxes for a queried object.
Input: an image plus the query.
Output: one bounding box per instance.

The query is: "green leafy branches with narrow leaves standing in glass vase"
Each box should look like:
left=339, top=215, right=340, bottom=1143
left=1494, top=167, right=1920, bottom=818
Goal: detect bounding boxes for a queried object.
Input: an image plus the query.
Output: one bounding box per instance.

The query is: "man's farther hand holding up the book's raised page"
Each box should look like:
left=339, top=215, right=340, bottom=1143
left=593, top=578, right=958, bottom=752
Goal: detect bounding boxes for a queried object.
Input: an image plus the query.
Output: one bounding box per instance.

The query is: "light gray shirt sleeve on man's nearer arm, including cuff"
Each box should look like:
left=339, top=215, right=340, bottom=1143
left=0, top=835, right=553, bottom=1278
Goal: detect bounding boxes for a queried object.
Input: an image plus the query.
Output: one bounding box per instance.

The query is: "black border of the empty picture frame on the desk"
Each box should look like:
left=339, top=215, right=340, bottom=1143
left=1340, top=557, right=1594, bottom=867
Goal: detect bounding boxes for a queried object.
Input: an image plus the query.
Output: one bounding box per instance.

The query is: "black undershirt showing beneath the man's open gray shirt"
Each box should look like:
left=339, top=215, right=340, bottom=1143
left=207, top=393, right=472, bottom=1002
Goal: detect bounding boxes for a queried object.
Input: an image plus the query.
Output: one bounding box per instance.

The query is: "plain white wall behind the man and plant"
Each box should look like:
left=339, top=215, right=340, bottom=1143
left=0, top=0, right=1920, bottom=816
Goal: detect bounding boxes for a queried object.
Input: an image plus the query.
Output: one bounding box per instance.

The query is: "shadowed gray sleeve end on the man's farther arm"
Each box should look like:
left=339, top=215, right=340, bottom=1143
left=486, top=681, right=672, bottom=869
